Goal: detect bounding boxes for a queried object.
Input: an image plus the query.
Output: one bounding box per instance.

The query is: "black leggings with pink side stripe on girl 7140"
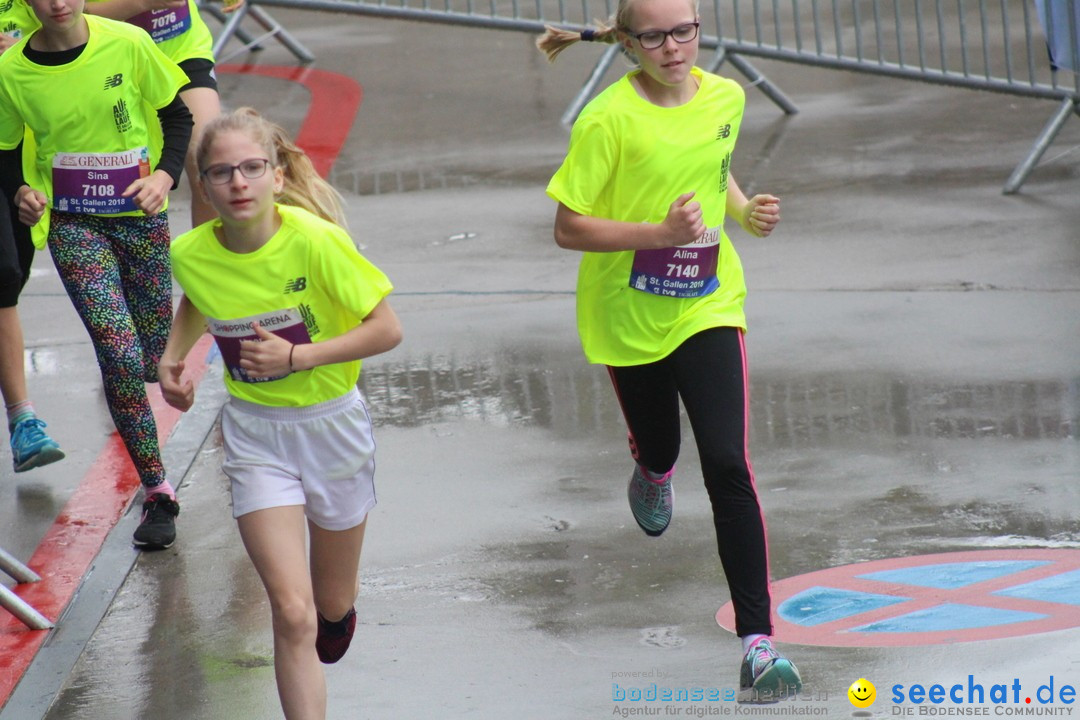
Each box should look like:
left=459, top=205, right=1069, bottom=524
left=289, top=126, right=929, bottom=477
left=608, top=327, right=772, bottom=637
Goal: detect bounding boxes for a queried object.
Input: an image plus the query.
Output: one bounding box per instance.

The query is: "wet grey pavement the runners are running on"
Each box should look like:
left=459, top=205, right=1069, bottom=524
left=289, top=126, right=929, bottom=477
left=0, top=11, right=1080, bottom=720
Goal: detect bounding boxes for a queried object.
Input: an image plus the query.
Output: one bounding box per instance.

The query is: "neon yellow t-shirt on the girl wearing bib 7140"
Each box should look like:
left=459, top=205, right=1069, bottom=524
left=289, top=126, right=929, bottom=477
left=548, top=68, right=746, bottom=366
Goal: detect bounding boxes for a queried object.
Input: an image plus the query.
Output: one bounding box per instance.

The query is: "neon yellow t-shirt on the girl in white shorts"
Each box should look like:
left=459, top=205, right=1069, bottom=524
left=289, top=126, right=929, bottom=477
left=172, top=204, right=393, bottom=407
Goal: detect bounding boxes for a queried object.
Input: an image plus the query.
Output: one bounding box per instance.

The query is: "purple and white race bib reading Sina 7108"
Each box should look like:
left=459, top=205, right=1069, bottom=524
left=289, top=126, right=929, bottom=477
left=53, top=148, right=150, bottom=215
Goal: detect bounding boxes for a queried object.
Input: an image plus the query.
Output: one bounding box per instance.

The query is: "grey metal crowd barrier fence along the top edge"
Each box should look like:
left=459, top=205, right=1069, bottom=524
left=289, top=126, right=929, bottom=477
left=210, top=0, right=1080, bottom=193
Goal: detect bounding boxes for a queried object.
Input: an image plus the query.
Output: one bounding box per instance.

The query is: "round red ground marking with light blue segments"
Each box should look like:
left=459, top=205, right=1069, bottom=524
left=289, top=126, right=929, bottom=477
left=716, top=548, right=1080, bottom=648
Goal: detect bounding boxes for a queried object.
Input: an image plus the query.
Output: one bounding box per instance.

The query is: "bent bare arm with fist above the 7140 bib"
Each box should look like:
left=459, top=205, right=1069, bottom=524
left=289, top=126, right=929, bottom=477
left=555, top=192, right=705, bottom=253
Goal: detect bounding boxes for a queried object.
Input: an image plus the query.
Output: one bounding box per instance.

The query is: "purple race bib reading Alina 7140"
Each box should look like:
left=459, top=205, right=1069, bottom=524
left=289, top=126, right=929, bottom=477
left=630, top=228, right=720, bottom=298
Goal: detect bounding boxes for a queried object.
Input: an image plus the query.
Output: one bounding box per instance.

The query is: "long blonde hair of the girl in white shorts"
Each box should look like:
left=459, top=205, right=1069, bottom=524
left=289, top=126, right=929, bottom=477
left=195, top=107, right=347, bottom=228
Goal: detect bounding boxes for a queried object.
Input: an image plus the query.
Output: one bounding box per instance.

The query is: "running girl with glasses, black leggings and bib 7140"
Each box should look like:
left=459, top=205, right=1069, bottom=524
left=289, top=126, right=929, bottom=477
left=537, top=0, right=801, bottom=702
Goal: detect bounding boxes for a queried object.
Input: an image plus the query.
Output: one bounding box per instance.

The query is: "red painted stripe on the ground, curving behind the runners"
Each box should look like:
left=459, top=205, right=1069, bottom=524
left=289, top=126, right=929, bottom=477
left=0, top=65, right=363, bottom=708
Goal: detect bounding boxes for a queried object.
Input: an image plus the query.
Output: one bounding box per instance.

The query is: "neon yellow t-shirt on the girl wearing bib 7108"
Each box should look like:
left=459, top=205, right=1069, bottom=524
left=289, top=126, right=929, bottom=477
left=0, top=15, right=187, bottom=241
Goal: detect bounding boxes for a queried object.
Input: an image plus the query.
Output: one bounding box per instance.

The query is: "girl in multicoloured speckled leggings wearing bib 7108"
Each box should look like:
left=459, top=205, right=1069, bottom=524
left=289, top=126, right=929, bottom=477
left=0, top=0, right=192, bottom=549
